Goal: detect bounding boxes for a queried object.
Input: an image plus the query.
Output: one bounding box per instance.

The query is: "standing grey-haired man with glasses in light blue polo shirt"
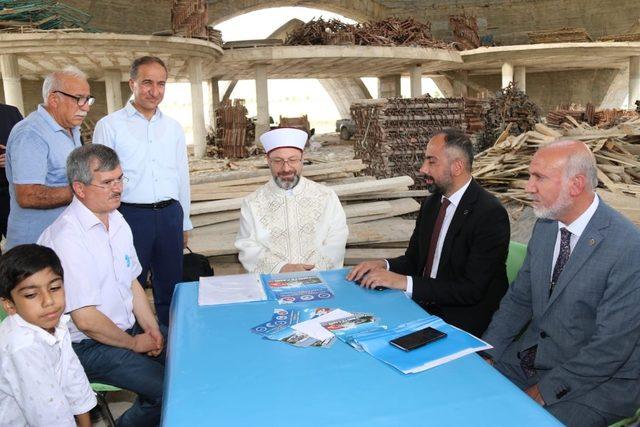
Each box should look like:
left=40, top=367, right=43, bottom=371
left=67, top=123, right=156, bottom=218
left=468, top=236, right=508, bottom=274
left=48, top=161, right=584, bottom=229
left=6, top=67, right=95, bottom=249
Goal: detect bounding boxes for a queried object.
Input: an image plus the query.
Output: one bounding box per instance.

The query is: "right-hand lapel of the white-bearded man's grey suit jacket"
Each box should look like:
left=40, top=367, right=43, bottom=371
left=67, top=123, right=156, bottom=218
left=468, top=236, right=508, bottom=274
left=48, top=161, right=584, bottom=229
left=547, top=205, right=609, bottom=307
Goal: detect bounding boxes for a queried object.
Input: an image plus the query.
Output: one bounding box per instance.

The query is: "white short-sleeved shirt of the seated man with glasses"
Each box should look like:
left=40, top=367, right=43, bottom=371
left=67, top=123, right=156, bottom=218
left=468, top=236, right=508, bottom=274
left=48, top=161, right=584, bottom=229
left=38, top=197, right=142, bottom=342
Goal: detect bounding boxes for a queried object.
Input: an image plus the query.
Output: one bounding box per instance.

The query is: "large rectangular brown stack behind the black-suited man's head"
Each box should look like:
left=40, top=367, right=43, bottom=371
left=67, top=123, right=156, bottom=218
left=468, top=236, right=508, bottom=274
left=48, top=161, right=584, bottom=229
left=351, top=96, right=466, bottom=189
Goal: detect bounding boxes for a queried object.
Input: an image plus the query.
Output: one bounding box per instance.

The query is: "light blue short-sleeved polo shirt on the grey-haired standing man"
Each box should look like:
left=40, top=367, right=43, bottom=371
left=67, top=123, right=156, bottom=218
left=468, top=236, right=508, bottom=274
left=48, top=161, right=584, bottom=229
left=6, top=105, right=81, bottom=249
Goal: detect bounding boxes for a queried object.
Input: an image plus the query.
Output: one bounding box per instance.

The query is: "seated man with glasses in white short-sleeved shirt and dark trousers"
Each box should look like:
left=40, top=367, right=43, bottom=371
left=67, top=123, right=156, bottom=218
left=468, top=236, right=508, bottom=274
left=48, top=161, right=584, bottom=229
left=38, top=144, right=166, bottom=427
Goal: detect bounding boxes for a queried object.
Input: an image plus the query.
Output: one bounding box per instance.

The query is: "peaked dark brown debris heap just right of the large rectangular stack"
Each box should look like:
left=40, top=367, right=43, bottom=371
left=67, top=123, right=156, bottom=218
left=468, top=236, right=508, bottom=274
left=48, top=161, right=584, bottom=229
left=476, top=82, right=540, bottom=152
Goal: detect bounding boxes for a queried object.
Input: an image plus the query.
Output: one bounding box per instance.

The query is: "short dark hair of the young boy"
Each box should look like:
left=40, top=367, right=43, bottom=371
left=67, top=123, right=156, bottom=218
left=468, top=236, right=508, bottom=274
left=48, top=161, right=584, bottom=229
left=0, top=243, right=64, bottom=301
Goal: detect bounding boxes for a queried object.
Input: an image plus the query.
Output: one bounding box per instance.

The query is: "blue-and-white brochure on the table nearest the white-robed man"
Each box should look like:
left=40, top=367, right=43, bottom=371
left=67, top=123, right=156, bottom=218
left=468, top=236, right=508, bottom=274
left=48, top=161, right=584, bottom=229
left=266, top=272, right=334, bottom=304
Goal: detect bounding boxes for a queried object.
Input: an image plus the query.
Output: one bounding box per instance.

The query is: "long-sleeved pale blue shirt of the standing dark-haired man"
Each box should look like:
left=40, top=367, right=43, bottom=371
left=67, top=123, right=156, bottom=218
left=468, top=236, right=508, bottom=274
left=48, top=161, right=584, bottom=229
left=93, top=102, right=193, bottom=231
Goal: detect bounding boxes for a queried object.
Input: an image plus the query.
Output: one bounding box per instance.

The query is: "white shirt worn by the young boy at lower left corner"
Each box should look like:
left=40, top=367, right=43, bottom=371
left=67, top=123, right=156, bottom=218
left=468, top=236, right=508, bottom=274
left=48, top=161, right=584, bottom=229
left=0, top=314, right=96, bottom=427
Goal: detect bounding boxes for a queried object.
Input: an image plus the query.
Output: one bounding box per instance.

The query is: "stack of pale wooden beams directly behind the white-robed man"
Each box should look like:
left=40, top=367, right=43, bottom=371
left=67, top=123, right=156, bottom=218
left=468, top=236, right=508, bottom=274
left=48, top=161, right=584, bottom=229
left=189, top=160, right=427, bottom=272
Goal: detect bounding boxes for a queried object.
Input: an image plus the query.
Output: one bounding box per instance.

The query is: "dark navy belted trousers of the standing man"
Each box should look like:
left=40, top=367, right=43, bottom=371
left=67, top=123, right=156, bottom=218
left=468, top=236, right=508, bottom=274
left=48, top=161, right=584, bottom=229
left=119, top=202, right=184, bottom=326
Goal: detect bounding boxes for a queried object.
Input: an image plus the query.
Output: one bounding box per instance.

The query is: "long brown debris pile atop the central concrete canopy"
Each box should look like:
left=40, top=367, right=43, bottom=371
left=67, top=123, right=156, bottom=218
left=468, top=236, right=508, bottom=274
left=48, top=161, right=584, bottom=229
left=284, top=17, right=449, bottom=49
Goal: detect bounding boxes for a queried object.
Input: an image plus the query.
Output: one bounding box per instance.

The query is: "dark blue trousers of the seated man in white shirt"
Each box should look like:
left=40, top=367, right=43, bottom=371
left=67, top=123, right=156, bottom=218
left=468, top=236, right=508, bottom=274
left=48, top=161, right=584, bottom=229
left=73, top=325, right=167, bottom=427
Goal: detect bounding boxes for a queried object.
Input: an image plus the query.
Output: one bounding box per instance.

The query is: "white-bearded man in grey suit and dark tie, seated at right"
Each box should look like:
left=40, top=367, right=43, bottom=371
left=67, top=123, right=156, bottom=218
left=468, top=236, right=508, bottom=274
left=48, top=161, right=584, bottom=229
left=484, top=141, right=640, bottom=426
